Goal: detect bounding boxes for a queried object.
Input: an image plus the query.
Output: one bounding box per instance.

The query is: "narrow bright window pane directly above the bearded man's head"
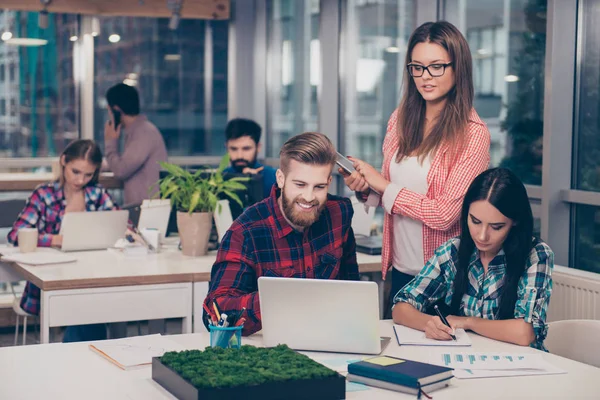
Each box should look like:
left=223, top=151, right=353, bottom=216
left=266, top=0, right=321, bottom=157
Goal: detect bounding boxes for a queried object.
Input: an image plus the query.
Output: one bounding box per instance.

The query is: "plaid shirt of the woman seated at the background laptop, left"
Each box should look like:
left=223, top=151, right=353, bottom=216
left=7, top=182, right=118, bottom=315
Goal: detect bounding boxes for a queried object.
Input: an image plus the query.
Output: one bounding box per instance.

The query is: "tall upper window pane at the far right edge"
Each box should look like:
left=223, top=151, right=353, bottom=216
left=573, top=1, right=600, bottom=191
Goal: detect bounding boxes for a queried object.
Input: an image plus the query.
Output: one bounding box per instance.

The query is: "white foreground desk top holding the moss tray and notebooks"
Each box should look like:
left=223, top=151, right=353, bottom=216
left=0, top=321, right=600, bottom=400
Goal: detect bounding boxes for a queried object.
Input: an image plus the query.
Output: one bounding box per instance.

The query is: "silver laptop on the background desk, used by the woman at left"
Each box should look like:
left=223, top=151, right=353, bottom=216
left=60, top=210, right=129, bottom=251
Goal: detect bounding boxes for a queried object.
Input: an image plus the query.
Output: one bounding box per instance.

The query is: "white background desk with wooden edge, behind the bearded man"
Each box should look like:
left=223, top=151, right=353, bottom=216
left=0, top=246, right=383, bottom=343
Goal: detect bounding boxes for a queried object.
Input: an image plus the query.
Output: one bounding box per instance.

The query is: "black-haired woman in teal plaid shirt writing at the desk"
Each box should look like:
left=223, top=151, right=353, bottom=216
left=392, top=168, right=554, bottom=349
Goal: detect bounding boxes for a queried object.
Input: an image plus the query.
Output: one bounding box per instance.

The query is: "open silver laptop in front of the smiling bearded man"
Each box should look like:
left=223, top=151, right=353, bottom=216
left=258, top=277, right=389, bottom=354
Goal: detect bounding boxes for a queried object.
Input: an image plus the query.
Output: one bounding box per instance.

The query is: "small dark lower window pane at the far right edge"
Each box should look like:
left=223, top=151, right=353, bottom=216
left=572, top=205, right=600, bottom=273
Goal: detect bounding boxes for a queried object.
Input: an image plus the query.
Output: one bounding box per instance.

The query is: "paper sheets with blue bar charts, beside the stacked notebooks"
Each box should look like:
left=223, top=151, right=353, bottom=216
left=431, top=353, right=566, bottom=379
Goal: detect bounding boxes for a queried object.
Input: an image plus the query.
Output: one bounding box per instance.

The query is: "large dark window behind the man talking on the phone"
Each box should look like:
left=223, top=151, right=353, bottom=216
left=94, top=17, right=228, bottom=156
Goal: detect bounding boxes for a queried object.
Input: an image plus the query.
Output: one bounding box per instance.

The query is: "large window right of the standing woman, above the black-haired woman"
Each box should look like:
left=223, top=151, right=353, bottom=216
left=445, top=0, right=547, bottom=185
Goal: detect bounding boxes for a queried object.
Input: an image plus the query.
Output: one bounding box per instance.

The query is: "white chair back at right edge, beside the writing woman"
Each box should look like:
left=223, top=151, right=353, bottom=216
left=544, top=319, right=600, bottom=367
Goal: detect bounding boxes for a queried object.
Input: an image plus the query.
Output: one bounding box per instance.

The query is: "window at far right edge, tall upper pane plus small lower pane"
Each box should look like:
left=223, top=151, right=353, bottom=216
left=573, top=0, right=600, bottom=273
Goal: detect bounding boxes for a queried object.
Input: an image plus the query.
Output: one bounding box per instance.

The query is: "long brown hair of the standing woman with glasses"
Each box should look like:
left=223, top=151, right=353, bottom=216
left=396, top=21, right=474, bottom=162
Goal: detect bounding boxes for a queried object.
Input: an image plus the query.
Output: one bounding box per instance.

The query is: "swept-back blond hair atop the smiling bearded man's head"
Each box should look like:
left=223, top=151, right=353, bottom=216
left=279, top=132, right=337, bottom=172
